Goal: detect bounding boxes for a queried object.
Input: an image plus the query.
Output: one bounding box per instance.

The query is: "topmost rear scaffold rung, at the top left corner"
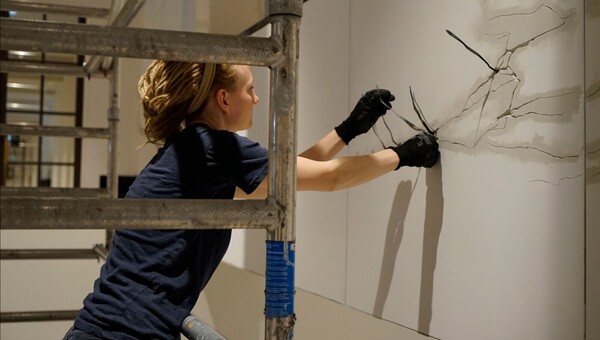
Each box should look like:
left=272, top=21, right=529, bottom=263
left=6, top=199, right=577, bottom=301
left=0, top=0, right=110, bottom=18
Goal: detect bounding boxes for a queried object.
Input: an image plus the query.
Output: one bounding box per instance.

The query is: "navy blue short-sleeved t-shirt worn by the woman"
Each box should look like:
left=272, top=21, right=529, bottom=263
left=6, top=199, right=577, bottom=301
left=75, top=125, right=268, bottom=339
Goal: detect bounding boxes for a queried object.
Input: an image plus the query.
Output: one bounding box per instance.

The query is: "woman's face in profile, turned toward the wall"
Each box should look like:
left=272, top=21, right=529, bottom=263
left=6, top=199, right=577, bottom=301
left=227, top=65, right=259, bottom=131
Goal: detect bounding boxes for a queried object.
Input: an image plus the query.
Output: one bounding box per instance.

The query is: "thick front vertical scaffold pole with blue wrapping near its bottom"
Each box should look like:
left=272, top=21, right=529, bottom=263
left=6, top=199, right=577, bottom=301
left=265, top=0, right=302, bottom=339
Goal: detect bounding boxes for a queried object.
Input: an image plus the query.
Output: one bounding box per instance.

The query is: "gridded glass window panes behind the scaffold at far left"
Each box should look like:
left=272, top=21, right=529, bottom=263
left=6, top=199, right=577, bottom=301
left=2, top=11, right=83, bottom=188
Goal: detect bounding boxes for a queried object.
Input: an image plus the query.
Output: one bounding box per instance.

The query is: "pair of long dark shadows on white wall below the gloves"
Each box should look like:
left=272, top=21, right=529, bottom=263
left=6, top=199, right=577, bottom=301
left=373, top=162, right=444, bottom=334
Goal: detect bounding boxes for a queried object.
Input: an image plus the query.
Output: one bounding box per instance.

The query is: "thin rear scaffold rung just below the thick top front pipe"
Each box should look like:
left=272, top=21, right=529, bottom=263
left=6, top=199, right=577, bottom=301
left=0, top=60, right=110, bottom=78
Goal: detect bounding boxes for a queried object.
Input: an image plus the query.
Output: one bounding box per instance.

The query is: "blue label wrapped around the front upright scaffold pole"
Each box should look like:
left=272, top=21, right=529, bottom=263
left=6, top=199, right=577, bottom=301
left=265, top=241, right=296, bottom=318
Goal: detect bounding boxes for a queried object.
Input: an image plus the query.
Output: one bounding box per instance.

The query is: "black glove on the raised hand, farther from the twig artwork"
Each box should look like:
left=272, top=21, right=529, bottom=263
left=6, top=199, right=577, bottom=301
left=335, top=89, right=395, bottom=144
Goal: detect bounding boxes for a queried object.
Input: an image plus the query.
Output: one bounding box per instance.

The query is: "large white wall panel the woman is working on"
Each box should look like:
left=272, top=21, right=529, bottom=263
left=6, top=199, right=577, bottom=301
left=209, top=0, right=598, bottom=339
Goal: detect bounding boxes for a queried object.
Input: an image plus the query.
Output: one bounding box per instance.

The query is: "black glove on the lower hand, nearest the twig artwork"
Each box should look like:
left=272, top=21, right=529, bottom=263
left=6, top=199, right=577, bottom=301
left=390, top=132, right=440, bottom=170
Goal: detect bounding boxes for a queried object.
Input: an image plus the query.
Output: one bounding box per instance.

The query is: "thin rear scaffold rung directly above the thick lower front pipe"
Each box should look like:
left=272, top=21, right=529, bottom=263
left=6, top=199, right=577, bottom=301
left=0, top=187, right=110, bottom=198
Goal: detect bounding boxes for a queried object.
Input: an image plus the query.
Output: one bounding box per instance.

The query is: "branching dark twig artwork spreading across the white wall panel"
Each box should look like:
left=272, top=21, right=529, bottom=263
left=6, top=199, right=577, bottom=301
left=374, top=5, right=584, bottom=185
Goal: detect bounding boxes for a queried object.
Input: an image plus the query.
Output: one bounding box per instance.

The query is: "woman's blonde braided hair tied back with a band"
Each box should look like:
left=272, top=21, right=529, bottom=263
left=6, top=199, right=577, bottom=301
left=138, top=60, right=237, bottom=144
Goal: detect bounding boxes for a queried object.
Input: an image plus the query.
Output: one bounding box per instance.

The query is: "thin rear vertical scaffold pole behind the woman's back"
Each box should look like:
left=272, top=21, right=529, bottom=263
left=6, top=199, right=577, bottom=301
left=106, top=58, right=120, bottom=249
